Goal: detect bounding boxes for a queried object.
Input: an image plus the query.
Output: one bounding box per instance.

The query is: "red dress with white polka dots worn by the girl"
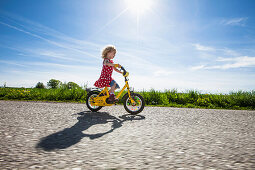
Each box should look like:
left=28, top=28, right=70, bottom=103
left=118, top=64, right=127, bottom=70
left=94, top=59, right=113, bottom=88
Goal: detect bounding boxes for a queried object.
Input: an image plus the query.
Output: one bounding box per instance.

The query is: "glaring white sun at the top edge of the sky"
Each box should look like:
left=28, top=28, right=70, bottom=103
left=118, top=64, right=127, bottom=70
left=125, top=0, right=153, bottom=15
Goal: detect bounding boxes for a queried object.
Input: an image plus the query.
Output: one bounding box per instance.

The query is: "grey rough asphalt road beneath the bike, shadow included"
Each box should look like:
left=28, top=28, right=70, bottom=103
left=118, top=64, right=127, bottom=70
left=0, top=101, right=255, bottom=170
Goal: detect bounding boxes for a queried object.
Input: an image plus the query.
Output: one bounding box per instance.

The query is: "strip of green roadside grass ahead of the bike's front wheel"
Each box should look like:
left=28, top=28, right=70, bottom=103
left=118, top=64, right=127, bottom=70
left=139, top=89, right=255, bottom=110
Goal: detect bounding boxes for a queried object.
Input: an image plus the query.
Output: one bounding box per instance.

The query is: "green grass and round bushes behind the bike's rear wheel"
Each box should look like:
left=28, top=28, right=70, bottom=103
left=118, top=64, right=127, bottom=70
left=0, top=79, right=87, bottom=102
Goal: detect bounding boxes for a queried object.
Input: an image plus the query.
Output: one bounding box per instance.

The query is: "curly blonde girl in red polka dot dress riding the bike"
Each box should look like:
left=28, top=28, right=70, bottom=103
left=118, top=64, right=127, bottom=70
left=94, top=45, right=122, bottom=102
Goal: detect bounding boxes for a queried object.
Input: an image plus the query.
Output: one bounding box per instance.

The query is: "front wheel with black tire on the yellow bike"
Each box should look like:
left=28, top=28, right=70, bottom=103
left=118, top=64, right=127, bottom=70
left=123, top=93, right=145, bottom=115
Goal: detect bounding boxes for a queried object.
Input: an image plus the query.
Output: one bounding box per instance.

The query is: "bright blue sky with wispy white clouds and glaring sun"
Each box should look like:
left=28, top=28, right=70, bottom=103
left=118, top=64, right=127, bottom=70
left=0, top=0, right=255, bottom=93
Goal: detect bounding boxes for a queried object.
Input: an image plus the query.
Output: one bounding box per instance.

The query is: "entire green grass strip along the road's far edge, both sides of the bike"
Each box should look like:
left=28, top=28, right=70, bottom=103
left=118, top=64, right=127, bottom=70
left=0, top=87, right=255, bottom=110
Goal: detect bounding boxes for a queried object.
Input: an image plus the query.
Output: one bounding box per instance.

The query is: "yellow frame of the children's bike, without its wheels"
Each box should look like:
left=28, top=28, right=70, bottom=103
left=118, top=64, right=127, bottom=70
left=90, top=79, right=135, bottom=106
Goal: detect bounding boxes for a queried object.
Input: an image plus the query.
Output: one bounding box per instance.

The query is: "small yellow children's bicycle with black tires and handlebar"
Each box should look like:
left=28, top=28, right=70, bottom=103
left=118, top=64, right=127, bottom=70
left=86, top=67, right=145, bottom=115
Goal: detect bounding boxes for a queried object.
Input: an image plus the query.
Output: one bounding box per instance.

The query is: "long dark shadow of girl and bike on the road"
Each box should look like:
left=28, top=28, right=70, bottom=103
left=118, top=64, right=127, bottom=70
left=36, top=112, right=145, bottom=151
